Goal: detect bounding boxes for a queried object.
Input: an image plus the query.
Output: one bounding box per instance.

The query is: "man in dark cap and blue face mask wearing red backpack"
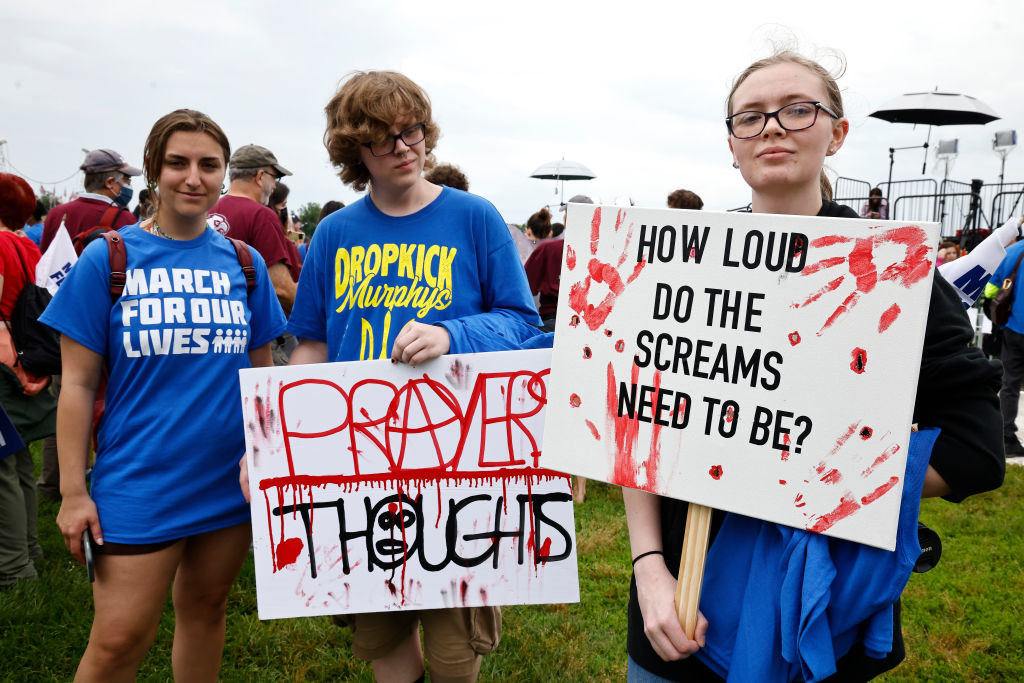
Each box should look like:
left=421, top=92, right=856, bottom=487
left=40, top=150, right=142, bottom=252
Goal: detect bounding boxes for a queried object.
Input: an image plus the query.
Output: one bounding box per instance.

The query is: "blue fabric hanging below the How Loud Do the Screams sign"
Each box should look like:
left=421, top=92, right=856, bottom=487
left=697, top=429, right=940, bottom=683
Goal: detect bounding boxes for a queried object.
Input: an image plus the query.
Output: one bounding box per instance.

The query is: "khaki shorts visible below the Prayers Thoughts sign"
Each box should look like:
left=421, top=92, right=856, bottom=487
left=345, top=607, right=502, bottom=681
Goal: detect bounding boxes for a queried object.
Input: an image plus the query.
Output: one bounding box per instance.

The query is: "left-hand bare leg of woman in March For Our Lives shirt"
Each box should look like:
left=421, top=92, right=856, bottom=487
left=75, top=541, right=185, bottom=682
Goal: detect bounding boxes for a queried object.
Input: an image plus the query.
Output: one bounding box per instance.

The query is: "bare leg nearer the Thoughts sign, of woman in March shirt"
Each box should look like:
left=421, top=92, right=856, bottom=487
left=171, top=523, right=251, bottom=681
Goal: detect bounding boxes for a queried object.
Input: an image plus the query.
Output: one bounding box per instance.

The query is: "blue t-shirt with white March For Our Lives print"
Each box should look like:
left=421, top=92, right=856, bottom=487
left=40, top=226, right=285, bottom=544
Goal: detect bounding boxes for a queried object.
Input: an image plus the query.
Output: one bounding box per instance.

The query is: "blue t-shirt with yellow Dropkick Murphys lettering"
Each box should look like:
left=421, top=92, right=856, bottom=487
left=288, top=187, right=541, bottom=360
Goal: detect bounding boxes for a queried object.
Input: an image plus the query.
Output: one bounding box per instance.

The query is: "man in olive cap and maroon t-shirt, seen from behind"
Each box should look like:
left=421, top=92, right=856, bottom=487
left=208, top=144, right=298, bottom=313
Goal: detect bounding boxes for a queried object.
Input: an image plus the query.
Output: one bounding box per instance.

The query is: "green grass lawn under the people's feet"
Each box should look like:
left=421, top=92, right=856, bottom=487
left=0, top=448, right=1024, bottom=681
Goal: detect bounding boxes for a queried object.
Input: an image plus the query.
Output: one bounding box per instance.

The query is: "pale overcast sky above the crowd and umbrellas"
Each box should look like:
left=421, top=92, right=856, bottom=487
left=0, top=0, right=1024, bottom=223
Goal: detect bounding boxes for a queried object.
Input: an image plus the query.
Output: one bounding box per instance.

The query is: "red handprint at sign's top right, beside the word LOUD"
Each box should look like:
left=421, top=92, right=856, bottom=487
left=791, top=225, right=932, bottom=336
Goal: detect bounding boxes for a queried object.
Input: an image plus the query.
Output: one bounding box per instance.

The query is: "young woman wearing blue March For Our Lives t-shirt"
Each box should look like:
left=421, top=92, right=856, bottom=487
left=42, top=110, right=285, bottom=681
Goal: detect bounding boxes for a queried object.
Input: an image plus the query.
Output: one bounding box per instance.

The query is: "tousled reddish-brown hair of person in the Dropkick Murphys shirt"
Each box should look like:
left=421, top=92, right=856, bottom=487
left=324, top=71, right=440, bottom=191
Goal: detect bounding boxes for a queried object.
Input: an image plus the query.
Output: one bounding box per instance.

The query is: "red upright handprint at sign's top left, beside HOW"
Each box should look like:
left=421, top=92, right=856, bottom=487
left=565, top=207, right=647, bottom=330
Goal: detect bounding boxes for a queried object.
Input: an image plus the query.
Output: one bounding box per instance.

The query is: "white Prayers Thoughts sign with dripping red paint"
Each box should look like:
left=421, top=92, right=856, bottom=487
left=240, top=349, right=580, bottom=618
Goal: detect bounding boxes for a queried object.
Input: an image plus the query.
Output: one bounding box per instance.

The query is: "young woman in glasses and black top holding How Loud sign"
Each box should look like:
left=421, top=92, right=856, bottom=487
left=623, top=51, right=1005, bottom=681
